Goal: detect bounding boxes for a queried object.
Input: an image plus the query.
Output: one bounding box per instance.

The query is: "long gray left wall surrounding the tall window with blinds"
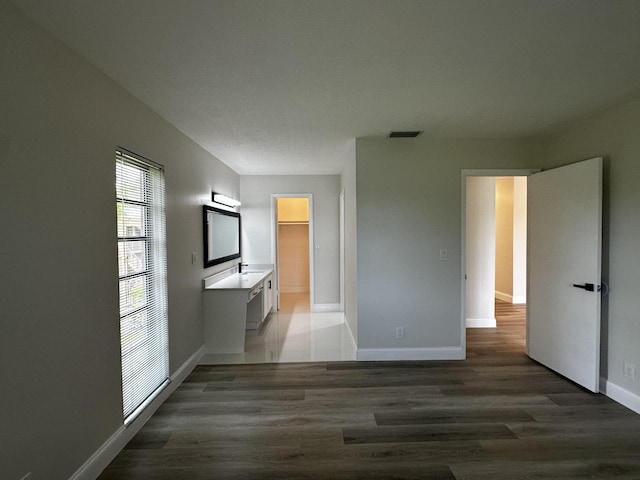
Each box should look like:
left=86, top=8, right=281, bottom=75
left=0, top=0, right=239, bottom=480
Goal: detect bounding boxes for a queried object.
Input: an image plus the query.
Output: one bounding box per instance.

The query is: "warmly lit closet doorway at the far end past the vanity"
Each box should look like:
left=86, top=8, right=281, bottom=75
left=272, top=194, right=314, bottom=309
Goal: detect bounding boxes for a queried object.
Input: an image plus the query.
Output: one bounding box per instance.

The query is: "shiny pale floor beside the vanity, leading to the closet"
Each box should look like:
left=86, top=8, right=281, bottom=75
left=200, top=292, right=356, bottom=365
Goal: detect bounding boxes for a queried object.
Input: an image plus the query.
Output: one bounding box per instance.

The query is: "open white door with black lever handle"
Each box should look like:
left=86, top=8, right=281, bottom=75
left=527, top=158, right=602, bottom=392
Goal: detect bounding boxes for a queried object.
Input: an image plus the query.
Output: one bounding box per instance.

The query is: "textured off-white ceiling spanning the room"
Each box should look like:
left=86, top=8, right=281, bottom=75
left=14, top=0, right=640, bottom=174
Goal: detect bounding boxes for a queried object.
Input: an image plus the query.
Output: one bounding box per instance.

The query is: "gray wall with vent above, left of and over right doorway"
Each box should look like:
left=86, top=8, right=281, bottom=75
left=356, top=136, right=530, bottom=358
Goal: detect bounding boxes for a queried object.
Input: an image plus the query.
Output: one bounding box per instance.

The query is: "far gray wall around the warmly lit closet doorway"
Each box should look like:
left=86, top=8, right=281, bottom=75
left=240, top=175, right=340, bottom=304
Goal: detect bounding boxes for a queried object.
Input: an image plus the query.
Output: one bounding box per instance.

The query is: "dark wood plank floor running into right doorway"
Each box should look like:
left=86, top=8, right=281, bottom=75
left=100, top=304, right=640, bottom=480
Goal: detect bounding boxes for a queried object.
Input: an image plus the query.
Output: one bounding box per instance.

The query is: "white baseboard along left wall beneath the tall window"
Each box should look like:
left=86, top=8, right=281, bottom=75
left=69, top=345, right=204, bottom=480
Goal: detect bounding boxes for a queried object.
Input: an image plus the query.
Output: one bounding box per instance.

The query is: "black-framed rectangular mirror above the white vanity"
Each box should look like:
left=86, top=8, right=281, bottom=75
left=202, top=205, right=240, bottom=268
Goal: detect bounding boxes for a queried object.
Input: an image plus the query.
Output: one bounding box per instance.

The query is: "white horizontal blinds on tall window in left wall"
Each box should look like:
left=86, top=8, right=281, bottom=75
left=116, top=150, right=169, bottom=424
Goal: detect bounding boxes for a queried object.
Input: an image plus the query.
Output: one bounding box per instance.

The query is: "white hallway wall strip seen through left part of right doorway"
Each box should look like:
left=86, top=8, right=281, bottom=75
left=466, top=177, right=496, bottom=327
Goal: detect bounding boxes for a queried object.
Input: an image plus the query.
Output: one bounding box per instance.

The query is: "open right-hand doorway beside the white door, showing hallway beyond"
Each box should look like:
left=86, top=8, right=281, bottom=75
left=461, top=170, right=535, bottom=351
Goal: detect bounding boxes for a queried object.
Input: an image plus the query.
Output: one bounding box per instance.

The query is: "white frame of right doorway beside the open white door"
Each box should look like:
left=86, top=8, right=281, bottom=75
left=460, top=168, right=541, bottom=358
